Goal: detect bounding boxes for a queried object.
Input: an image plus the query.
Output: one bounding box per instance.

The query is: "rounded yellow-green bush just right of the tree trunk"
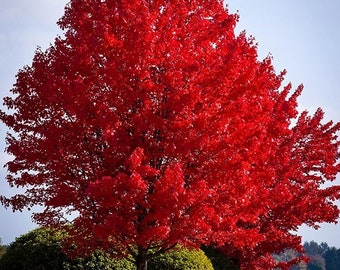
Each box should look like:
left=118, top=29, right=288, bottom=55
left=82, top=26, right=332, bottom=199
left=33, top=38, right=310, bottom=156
left=148, top=247, right=214, bottom=270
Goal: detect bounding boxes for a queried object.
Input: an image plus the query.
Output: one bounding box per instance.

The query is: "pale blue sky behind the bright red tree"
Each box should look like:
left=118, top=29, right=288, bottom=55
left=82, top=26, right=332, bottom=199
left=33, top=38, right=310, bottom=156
left=0, top=0, right=340, bottom=248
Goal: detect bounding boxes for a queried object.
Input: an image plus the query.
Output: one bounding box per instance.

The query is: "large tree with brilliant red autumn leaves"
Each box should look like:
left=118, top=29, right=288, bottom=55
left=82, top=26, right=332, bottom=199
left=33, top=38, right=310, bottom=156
left=0, top=0, right=340, bottom=270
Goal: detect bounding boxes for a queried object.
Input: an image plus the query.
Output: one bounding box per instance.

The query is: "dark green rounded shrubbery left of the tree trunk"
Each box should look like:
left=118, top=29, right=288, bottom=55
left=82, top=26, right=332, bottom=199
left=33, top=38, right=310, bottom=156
left=0, top=228, right=134, bottom=270
